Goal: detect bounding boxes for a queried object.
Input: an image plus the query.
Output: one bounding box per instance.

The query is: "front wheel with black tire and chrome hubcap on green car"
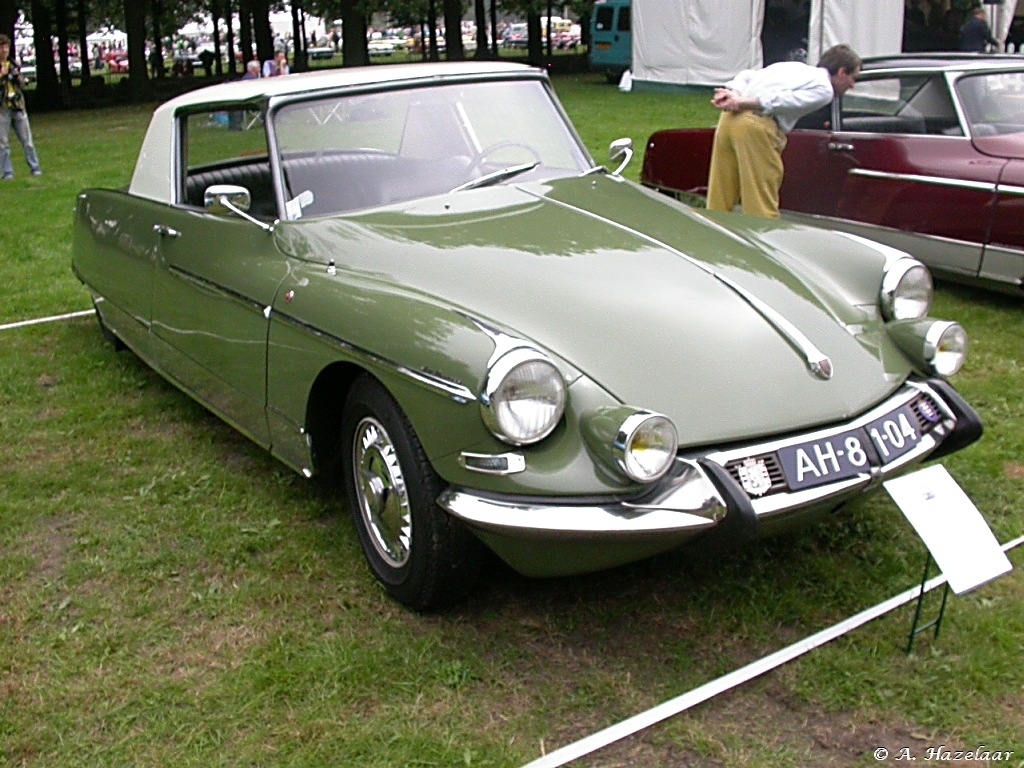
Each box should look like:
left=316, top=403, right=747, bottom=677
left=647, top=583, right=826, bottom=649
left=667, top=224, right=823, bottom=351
left=341, top=376, right=483, bottom=610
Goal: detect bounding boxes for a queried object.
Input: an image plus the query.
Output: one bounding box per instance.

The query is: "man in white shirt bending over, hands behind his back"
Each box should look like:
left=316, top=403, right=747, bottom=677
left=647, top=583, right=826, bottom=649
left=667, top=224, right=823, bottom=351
left=708, top=45, right=861, bottom=218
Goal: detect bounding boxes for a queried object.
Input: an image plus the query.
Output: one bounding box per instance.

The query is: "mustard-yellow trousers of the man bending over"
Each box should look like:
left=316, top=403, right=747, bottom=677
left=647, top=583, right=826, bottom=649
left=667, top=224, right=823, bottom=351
left=708, top=112, right=785, bottom=218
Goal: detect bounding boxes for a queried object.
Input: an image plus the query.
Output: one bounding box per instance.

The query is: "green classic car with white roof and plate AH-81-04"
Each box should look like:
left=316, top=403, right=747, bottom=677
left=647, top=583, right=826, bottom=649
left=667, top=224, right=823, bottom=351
left=74, top=62, right=981, bottom=609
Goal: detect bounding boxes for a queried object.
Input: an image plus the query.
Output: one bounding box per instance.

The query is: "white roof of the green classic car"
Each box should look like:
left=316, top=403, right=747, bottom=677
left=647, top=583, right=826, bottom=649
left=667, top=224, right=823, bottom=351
left=128, top=61, right=542, bottom=203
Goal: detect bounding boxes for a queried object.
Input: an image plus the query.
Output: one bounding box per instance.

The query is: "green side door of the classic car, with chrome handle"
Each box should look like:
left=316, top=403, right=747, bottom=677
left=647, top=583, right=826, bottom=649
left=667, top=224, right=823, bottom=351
left=146, top=109, right=288, bottom=445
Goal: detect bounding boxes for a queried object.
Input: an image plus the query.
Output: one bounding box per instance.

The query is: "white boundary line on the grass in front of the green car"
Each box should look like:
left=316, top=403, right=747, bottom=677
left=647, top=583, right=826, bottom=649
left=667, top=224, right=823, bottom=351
left=523, top=537, right=1024, bottom=768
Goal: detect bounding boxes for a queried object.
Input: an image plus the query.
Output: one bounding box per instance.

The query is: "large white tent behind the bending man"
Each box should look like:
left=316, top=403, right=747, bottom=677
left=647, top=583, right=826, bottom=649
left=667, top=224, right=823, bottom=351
left=633, top=0, right=905, bottom=86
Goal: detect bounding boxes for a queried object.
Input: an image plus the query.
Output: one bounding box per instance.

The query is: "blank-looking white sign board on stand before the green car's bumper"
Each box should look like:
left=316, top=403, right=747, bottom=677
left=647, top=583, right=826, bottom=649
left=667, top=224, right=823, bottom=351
left=883, top=464, right=1013, bottom=595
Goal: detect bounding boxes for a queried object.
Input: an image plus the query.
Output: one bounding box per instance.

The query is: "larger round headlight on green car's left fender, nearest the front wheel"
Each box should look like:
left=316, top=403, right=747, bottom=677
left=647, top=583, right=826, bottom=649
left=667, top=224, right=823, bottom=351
left=480, top=348, right=565, bottom=445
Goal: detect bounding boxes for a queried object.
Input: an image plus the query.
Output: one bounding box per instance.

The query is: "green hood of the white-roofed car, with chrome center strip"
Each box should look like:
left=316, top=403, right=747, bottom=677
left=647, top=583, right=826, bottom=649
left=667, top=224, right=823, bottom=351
left=275, top=175, right=910, bottom=445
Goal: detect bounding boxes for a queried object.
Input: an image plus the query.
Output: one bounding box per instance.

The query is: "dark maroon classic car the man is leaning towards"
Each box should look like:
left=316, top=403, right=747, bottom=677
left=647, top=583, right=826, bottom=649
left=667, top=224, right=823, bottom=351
left=641, top=53, right=1024, bottom=295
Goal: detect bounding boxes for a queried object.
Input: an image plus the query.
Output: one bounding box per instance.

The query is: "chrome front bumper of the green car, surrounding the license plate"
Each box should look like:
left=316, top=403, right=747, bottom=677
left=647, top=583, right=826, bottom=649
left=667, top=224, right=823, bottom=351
left=438, top=380, right=982, bottom=575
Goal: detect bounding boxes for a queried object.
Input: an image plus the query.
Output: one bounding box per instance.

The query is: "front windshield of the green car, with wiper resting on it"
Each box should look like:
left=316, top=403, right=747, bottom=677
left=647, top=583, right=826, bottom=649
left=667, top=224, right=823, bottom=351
left=272, top=80, right=591, bottom=219
